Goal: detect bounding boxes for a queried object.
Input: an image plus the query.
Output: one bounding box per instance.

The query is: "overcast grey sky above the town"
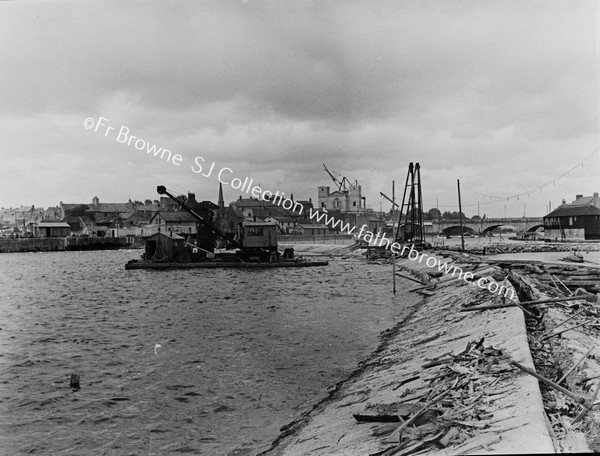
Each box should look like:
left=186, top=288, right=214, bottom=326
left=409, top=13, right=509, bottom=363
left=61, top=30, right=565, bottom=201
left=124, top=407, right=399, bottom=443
left=0, top=0, right=600, bottom=216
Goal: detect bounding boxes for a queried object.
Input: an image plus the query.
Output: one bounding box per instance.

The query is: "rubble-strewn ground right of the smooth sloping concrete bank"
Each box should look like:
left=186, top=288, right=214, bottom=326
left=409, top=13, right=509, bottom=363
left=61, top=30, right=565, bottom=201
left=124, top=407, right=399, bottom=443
left=511, top=267, right=600, bottom=453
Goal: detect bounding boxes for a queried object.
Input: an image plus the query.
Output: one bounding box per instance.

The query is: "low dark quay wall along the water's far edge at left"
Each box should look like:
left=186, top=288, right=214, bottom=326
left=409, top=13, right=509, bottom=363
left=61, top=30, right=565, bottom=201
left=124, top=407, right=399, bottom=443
left=0, top=237, right=134, bottom=253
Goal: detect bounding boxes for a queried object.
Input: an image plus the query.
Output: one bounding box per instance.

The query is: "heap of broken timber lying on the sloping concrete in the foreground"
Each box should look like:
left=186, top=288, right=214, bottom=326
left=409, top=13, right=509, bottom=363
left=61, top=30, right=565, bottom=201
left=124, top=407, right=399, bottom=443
left=353, top=338, right=514, bottom=456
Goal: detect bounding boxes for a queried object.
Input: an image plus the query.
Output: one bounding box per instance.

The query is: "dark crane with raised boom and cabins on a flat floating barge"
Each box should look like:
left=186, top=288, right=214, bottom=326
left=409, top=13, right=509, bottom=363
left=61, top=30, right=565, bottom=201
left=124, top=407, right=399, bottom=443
left=125, top=185, right=328, bottom=269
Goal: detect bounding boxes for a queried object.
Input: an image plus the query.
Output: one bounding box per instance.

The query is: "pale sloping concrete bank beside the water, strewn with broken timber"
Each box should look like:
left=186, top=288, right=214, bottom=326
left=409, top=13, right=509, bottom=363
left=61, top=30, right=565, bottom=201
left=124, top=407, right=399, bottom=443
left=261, top=253, right=589, bottom=456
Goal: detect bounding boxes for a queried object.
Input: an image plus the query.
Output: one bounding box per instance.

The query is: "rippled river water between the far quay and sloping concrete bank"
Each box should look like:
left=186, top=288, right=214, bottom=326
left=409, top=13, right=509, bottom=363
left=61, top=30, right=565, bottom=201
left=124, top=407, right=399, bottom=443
left=0, top=251, right=416, bottom=456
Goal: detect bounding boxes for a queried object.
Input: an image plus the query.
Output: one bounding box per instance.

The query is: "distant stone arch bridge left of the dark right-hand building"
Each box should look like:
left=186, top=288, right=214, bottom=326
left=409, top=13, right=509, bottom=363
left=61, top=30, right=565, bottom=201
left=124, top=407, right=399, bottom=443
left=425, top=217, right=544, bottom=234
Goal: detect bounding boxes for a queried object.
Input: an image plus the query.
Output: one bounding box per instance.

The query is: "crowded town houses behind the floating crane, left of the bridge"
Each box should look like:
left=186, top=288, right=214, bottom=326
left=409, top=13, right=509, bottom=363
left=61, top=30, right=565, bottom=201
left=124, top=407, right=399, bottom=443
left=0, top=188, right=384, bottom=237
